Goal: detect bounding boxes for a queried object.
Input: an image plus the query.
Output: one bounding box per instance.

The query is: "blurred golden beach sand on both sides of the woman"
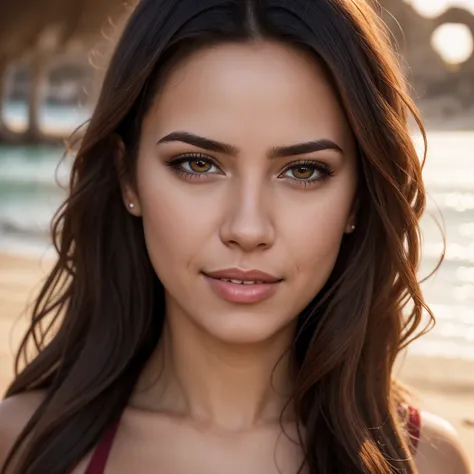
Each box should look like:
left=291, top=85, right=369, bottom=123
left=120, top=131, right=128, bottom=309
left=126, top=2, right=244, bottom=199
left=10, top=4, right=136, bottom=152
left=0, top=253, right=474, bottom=466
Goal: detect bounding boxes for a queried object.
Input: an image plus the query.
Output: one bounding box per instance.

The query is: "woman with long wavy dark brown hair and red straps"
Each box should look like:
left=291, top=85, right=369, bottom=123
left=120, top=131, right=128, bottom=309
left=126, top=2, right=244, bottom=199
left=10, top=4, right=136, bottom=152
left=0, top=0, right=468, bottom=474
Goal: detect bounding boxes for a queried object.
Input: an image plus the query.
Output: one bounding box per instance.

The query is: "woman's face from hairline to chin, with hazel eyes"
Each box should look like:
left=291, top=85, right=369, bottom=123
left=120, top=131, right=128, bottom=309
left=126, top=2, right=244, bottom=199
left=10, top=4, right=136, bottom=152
left=125, top=43, right=357, bottom=343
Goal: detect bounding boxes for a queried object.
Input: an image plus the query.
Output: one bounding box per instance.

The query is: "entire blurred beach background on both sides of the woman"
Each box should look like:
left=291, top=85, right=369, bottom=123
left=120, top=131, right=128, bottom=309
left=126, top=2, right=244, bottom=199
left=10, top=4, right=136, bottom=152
left=0, top=0, right=474, bottom=466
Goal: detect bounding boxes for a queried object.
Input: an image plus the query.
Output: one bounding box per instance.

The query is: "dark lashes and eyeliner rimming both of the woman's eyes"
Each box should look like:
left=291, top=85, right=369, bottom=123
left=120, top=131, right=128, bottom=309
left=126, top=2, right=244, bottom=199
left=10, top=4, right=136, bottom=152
left=165, top=153, right=334, bottom=187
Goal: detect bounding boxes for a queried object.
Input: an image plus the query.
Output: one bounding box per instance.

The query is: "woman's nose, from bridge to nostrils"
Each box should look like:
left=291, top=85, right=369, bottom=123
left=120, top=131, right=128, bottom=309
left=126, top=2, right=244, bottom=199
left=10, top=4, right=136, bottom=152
left=220, top=184, right=275, bottom=252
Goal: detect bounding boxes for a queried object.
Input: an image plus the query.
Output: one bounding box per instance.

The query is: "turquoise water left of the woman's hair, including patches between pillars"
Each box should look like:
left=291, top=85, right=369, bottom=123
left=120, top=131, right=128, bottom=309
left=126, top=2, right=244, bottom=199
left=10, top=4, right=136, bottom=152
left=0, top=102, right=86, bottom=253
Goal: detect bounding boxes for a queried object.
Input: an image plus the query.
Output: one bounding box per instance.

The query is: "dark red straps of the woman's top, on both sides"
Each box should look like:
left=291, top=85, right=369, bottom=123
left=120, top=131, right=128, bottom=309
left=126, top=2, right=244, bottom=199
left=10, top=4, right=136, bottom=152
left=81, top=406, right=421, bottom=474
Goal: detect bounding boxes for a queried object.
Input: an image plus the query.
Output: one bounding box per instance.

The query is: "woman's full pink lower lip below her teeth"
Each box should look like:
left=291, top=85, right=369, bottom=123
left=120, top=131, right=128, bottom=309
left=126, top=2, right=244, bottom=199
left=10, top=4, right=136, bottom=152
left=204, top=275, right=280, bottom=303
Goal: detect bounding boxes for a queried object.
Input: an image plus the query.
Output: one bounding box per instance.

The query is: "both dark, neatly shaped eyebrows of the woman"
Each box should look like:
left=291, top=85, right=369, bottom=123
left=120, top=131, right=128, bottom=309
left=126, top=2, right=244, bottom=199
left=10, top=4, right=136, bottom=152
left=157, top=132, right=344, bottom=158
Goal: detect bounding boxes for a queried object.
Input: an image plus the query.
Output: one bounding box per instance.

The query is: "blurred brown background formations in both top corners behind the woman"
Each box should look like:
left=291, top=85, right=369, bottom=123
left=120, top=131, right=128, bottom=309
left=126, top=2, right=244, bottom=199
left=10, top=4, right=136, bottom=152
left=0, top=0, right=474, bottom=143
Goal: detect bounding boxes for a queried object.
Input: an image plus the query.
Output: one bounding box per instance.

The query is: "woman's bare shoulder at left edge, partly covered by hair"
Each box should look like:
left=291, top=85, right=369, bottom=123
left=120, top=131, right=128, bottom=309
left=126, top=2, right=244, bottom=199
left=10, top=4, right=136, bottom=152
left=0, top=391, right=45, bottom=470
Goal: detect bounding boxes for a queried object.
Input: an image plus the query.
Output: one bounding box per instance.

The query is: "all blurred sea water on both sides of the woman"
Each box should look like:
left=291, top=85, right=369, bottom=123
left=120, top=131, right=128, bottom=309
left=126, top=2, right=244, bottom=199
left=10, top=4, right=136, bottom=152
left=0, top=107, right=474, bottom=360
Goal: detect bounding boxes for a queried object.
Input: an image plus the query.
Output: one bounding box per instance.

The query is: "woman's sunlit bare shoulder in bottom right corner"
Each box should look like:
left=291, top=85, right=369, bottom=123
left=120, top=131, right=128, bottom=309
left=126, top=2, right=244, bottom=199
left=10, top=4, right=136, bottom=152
left=415, top=412, right=471, bottom=474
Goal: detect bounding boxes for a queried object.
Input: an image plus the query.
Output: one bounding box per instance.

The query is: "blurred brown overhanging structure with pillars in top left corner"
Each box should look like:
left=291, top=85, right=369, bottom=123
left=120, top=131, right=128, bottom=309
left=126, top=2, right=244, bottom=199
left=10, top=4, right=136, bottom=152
left=0, top=0, right=128, bottom=143
